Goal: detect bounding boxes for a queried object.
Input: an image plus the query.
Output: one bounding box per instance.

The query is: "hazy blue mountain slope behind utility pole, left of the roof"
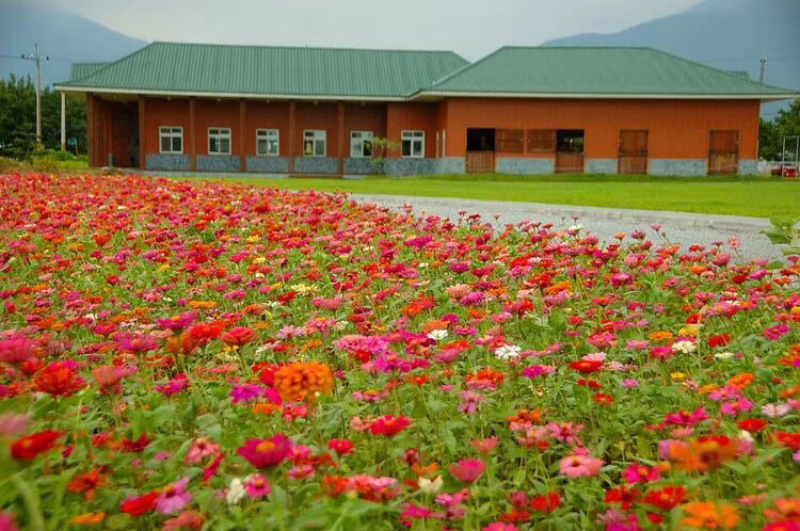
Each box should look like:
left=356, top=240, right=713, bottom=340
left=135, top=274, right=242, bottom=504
left=0, top=2, right=147, bottom=85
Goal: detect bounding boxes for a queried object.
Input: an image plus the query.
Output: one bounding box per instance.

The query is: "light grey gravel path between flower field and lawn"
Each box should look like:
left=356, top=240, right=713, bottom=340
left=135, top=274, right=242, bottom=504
left=351, top=194, right=782, bottom=262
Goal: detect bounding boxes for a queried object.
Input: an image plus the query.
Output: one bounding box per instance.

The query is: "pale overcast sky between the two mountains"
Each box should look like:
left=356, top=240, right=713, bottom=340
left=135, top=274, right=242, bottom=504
left=21, top=0, right=700, bottom=59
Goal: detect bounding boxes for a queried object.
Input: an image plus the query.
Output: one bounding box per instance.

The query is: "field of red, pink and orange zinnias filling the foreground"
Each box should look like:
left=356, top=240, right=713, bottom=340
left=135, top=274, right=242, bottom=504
left=0, top=174, right=800, bottom=531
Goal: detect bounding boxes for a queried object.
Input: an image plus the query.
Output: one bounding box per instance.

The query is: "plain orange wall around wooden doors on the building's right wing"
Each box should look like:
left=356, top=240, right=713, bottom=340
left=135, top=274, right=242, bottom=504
left=447, top=98, right=759, bottom=159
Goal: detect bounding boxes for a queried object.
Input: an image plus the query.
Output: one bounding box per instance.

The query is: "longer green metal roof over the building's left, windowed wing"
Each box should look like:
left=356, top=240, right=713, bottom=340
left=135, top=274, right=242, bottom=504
left=57, top=42, right=467, bottom=99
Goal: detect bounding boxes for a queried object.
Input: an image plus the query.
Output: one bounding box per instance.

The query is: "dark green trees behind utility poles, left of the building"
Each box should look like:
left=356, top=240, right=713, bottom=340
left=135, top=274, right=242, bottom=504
left=0, top=74, right=86, bottom=159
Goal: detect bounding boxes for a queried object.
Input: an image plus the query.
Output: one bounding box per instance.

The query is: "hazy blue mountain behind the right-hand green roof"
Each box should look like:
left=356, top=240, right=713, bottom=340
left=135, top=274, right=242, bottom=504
left=544, top=0, right=800, bottom=118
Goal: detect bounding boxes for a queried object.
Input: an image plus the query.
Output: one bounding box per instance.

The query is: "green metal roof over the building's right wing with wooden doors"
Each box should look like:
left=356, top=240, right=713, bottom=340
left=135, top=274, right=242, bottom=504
left=421, top=46, right=800, bottom=99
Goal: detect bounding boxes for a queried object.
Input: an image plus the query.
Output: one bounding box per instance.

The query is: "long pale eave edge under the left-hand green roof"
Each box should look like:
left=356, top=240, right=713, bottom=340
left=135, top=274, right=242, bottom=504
left=54, top=84, right=409, bottom=102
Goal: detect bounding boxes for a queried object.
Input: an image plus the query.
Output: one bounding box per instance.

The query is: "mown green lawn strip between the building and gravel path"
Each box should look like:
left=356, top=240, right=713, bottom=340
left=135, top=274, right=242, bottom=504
left=208, top=175, right=800, bottom=217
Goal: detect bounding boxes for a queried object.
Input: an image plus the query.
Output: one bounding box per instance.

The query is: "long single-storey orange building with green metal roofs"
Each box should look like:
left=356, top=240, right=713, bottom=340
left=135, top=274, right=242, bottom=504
left=56, top=43, right=800, bottom=175
